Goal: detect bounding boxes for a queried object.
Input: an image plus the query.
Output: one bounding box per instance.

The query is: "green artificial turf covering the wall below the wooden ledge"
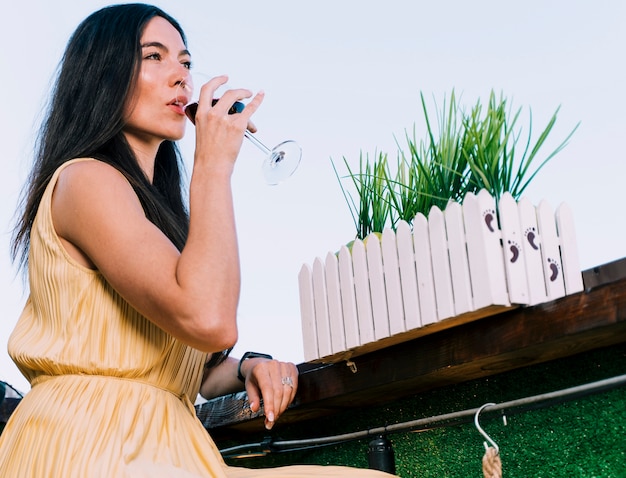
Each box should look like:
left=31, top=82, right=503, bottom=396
left=220, top=344, right=626, bottom=478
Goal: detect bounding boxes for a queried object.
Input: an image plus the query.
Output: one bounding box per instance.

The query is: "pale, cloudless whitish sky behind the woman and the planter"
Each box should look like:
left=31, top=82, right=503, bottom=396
left=0, top=0, right=626, bottom=391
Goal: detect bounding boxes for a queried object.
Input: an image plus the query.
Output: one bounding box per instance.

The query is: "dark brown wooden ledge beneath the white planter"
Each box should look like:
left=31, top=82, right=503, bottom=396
left=196, top=259, right=626, bottom=438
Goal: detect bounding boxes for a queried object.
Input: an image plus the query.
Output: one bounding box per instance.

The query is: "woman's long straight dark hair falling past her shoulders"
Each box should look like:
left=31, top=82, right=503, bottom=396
left=11, top=3, right=189, bottom=267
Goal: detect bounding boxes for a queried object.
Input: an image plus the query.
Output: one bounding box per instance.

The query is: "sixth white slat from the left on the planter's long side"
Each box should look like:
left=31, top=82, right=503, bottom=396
left=365, top=233, right=389, bottom=340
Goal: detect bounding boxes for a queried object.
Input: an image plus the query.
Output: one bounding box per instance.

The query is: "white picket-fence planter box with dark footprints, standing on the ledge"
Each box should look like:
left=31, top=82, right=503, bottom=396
left=298, top=190, right=583, bottom=362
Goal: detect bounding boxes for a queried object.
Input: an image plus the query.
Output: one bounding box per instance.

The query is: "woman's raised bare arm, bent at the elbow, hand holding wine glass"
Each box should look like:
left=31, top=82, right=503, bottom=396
left=52, top=76, right=262, bottom=352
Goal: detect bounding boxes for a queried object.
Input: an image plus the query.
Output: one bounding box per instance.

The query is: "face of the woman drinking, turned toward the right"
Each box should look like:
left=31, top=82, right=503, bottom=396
left=124, top=17, right=191, bottom=147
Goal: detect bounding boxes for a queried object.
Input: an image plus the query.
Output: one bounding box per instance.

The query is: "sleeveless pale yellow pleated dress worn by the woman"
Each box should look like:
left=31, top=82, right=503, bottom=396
left=0, top=159, right=389, bottom=478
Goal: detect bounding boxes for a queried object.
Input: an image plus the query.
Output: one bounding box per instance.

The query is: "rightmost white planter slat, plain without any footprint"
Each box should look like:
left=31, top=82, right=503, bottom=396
left=556, top=203, right=584, bottom=294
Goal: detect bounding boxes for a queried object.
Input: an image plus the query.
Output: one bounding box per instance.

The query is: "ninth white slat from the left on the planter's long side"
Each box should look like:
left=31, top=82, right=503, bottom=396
left=413, top=214, right=437, bottom=326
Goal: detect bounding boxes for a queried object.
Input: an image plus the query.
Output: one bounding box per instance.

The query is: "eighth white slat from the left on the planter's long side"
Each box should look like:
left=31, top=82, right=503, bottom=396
left=396, top=221, right=422, bottom=330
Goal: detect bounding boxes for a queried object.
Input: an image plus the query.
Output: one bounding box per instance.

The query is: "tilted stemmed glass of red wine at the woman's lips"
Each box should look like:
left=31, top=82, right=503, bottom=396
left=176, top=72, right=302, bottom=186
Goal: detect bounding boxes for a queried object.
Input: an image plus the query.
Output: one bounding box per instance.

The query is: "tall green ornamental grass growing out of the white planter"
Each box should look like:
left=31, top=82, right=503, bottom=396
left=331, top=91, right=578, bottom=239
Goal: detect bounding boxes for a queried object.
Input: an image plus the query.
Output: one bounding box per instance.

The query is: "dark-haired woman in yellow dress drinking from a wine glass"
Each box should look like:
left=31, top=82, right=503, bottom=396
left=0, top=4, right=385, bottom=477
